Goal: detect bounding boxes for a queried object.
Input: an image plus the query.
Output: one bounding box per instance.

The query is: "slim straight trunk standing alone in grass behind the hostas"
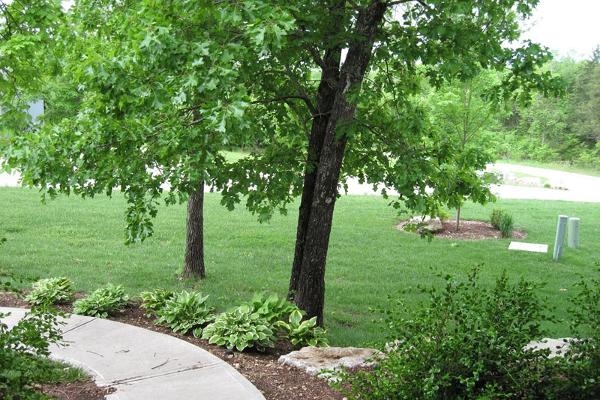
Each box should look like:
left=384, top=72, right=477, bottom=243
left=182, top=181, right=206, bottom=278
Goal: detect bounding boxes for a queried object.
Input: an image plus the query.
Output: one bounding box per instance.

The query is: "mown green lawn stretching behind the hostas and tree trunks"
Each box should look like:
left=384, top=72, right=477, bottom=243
left=0, top=188, right=600, bottom=345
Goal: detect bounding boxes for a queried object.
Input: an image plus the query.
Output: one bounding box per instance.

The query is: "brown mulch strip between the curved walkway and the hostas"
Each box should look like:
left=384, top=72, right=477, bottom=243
left=0, top=293, right=344, bottom=400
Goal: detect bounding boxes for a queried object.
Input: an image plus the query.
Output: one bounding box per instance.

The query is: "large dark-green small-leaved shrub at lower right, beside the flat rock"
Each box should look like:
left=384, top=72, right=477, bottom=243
left=338, top=270, right=558, bottom=400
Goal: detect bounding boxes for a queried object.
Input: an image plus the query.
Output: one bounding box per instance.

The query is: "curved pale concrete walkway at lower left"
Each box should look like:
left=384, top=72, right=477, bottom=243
left=0, top=307, right=264, bottom=400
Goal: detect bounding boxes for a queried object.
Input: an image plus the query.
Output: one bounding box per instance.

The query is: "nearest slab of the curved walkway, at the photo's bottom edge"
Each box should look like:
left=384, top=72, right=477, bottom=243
left=106, top=363, right=264, bottom=400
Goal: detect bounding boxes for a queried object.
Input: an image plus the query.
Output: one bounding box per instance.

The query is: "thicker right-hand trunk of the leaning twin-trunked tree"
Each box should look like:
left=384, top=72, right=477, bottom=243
left=294, top=0, right=387, bottom=325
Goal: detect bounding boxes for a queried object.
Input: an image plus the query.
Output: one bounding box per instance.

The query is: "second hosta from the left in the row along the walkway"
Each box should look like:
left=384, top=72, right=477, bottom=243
left=73, top=284, right=129, bottom=318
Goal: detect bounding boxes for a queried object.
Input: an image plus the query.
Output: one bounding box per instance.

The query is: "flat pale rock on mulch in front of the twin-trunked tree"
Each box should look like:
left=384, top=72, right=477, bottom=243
left=279, top=347, right=382, bottom=375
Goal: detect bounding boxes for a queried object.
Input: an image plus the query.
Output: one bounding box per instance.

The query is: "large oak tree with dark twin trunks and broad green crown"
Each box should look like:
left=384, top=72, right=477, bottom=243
left=2, top=0, right=554, bottom=323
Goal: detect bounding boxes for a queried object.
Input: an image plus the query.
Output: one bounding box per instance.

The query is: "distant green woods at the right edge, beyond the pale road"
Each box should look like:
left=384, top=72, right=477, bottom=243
left=494, top=47, right=600, bottom=168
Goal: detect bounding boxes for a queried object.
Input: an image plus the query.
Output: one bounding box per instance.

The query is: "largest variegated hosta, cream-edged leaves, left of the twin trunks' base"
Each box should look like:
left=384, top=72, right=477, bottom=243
left=202, top=304, right=275, bottom=351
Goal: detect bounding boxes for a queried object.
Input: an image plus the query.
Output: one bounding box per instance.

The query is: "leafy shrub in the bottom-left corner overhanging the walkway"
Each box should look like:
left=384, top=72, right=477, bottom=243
left=0, top=308, right=61, bottom=400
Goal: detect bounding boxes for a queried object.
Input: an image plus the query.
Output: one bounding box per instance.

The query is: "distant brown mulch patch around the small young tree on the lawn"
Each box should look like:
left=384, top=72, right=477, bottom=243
left=396, top=220, right=527, bottom=240
